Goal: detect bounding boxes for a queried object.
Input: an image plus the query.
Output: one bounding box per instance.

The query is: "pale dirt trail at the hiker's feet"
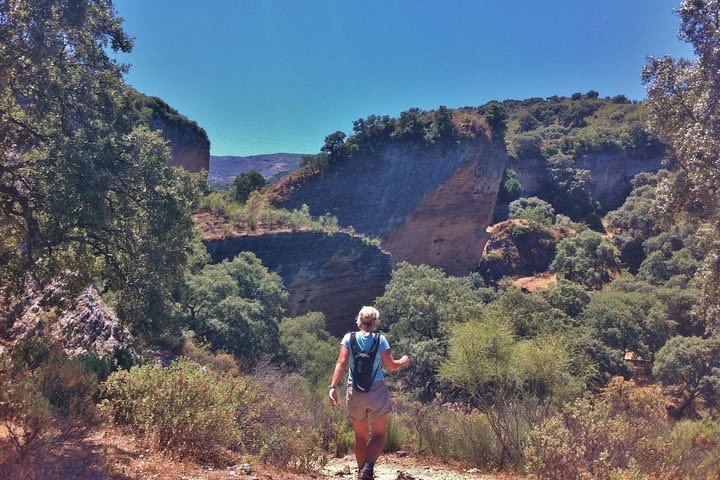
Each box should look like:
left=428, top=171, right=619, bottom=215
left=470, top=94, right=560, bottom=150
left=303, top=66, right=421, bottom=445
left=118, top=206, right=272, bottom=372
left=323, top=453, right=526, bottom=480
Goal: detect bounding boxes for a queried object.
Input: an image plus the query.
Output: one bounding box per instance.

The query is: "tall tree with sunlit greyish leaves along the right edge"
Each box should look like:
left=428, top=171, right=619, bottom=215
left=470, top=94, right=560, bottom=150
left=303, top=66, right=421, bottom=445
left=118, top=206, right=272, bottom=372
left=643, top=0, right=720, bottom=330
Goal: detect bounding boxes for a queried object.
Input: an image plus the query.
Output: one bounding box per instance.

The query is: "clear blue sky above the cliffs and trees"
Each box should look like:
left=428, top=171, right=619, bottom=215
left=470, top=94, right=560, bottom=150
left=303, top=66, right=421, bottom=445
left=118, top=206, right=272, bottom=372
left=115, top=0, right=691, bottom=155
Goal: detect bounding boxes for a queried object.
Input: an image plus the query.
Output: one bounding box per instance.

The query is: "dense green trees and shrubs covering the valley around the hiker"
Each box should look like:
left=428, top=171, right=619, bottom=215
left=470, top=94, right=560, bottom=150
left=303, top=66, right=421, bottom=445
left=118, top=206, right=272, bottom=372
left=0, top=0, right=720, bottom=479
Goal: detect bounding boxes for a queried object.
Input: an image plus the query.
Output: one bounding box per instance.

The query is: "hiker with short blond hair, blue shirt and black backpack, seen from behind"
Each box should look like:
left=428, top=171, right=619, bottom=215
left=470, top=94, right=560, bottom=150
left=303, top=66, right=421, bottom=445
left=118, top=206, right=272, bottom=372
left=330, top=307, right=410, bottom=480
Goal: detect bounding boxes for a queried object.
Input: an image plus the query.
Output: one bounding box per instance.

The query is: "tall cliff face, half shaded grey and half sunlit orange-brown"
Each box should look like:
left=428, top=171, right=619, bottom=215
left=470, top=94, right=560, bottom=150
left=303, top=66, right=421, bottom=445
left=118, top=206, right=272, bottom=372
left=281, top=136, right=507, bottom=275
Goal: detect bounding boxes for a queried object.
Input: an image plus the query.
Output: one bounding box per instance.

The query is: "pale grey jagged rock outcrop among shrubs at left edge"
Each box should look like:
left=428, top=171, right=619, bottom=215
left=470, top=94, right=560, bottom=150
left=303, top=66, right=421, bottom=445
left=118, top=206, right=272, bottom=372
left=0, top=285, right=134, bottom=359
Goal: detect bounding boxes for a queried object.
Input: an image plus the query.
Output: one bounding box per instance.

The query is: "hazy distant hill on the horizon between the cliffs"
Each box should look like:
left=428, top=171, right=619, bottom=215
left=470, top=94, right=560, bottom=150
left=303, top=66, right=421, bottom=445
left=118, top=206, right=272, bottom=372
left=208, top=153, right=304, bottom=187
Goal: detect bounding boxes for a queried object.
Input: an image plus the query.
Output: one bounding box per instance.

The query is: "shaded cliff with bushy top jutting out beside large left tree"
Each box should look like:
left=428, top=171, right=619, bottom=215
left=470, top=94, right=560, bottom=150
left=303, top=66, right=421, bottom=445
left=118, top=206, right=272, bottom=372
left=145, top=97, right=210, bottom=172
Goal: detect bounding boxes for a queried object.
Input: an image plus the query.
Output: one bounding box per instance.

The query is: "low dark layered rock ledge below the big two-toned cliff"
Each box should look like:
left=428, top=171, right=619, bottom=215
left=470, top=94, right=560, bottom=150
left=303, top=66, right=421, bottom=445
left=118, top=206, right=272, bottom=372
left=205, top=233, right=391, bottom=335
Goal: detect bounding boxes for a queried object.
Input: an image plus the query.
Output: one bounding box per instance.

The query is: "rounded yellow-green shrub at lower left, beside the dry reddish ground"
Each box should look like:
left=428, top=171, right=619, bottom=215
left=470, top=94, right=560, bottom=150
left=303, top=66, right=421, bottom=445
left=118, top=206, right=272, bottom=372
left=101, top=359, right=241, bottom=460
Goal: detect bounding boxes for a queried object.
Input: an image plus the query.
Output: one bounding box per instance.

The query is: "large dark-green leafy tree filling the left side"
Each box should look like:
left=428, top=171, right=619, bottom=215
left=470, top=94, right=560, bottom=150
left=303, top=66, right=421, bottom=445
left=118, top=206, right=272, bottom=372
left=0, top=0, right=198, bottom=334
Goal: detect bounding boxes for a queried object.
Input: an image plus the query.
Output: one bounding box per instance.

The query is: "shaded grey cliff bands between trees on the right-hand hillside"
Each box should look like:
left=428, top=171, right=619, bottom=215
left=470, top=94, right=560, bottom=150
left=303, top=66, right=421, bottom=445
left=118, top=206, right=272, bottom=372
left=509, top=152, right=662, bottom=209
